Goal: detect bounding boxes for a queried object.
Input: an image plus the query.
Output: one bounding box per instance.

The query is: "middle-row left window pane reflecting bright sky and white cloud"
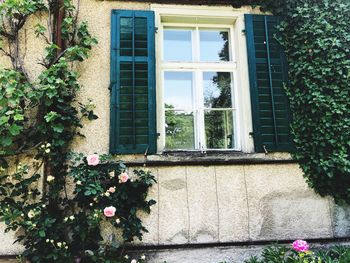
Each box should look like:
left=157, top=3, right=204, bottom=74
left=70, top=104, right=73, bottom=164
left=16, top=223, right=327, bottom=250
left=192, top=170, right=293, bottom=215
left=164, top=72, right=193, bottom=110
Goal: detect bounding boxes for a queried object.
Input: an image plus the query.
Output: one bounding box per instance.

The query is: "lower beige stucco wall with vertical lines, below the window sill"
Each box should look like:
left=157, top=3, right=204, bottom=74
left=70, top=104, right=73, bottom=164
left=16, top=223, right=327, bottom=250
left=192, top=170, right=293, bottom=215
left=0, top=164, right=350, bottom=255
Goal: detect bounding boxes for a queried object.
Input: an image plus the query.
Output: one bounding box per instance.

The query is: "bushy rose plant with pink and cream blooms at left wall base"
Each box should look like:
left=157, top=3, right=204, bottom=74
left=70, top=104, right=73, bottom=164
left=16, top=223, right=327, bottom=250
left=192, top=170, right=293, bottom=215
left=0, top=153, right=156, bottom=263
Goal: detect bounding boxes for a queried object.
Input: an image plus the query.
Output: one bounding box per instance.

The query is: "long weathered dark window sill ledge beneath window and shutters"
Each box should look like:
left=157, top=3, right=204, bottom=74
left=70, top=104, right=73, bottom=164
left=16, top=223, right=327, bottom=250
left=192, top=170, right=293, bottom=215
left=126, top=151, right=296, bottom=166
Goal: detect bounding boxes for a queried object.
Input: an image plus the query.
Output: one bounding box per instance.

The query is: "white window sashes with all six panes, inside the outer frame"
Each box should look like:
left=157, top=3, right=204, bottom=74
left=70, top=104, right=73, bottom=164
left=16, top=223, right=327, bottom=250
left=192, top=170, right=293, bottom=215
left=158, top=27, right=238, bottom=150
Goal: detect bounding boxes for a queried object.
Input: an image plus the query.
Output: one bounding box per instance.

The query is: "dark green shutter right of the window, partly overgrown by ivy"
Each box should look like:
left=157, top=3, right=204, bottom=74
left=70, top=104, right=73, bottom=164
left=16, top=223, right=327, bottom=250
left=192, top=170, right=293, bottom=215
left=245, top=15, right=293, bottom=152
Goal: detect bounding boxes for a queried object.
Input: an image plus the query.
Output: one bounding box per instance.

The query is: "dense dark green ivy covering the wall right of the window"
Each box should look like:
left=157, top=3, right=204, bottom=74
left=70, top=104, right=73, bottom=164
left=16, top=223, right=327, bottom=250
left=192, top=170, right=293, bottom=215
left=279, top=0, right=350, bottom=204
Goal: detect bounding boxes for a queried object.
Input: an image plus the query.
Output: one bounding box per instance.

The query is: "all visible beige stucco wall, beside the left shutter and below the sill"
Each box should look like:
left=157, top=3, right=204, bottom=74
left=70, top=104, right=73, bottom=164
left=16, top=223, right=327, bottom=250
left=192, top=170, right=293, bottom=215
left=0, top=0, right=350, bottom=255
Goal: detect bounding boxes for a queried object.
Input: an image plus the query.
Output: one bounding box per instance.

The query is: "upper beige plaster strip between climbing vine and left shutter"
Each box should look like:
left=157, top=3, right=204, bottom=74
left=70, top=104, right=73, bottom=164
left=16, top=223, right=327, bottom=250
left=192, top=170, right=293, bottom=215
left=74, top=0, right=150, bottom=155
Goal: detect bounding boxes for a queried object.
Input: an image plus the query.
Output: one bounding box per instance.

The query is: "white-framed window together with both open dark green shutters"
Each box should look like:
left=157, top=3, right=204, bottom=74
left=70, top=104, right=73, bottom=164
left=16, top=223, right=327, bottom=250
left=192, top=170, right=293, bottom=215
left=110, top=5, right=290, bottom=154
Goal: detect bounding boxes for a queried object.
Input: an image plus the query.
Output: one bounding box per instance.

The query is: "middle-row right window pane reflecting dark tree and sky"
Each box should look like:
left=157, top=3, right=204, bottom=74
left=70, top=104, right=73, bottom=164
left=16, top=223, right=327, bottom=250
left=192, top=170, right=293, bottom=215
left=203, top=72, right=232, bottom=108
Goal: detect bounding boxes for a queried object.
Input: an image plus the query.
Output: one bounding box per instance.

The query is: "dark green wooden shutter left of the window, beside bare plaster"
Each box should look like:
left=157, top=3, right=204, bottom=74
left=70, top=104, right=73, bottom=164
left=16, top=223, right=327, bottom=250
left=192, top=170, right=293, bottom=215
left=110, top=10, right=156, bottom=154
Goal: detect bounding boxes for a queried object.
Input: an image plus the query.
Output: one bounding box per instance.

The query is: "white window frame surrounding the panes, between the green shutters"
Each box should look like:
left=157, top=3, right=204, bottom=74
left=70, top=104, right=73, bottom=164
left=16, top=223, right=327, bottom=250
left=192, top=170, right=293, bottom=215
left=151, top=4, right=254, bottom=152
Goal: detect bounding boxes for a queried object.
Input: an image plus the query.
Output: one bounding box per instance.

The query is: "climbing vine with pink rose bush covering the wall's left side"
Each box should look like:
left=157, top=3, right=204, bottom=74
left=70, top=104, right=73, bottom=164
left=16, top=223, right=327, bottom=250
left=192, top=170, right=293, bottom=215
left=0, top=0, right=155, bottom=263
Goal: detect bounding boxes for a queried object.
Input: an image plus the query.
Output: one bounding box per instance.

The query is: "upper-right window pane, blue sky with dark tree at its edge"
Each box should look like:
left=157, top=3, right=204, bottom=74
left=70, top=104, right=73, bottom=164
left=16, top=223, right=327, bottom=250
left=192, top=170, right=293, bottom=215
left=199, top=30, right=230, bottom=61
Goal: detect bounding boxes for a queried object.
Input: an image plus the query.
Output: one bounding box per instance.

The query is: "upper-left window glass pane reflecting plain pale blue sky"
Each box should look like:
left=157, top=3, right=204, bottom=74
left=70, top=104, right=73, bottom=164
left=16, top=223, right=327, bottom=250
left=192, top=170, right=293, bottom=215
left=163, top=29, right=192, bottom=61
